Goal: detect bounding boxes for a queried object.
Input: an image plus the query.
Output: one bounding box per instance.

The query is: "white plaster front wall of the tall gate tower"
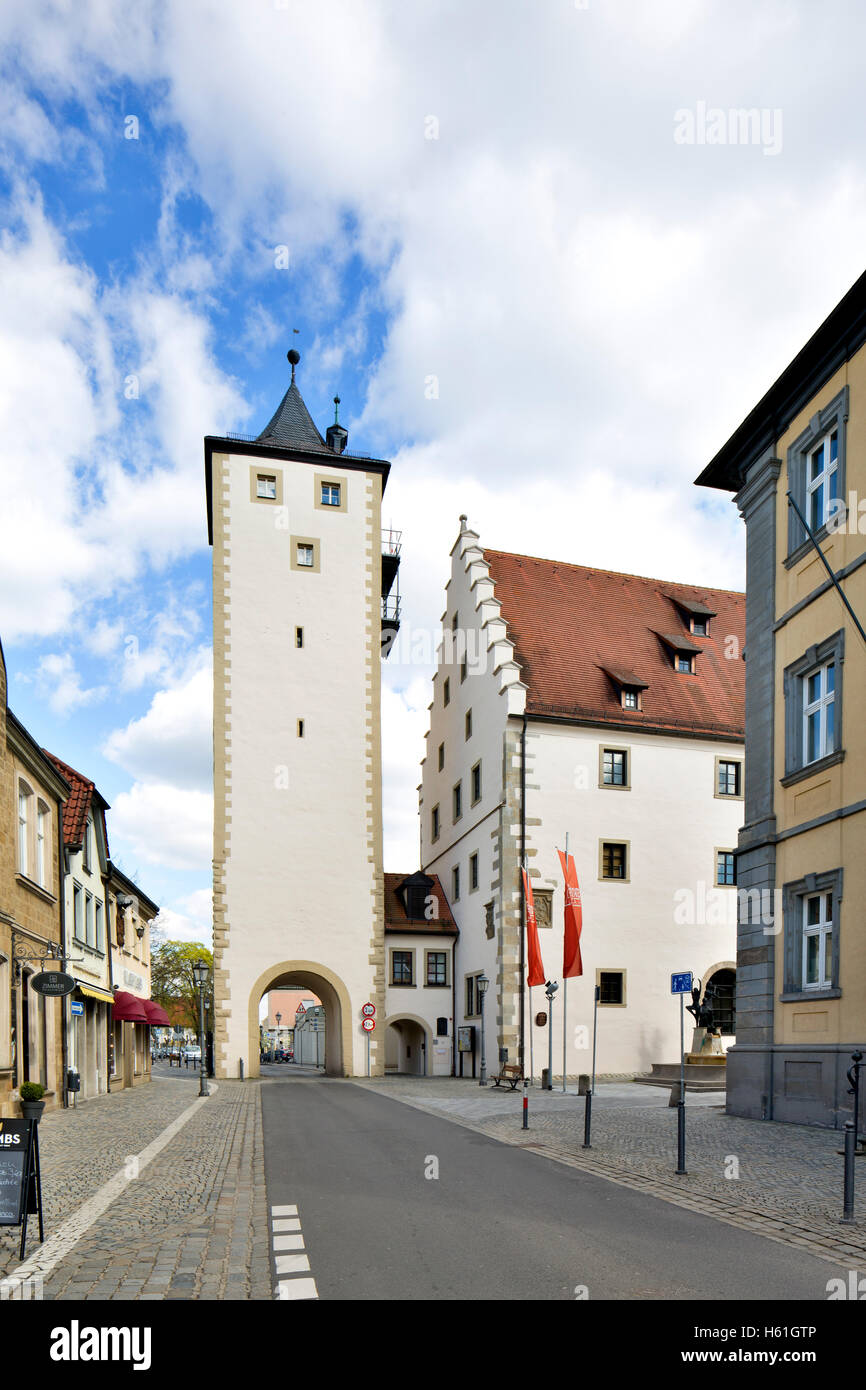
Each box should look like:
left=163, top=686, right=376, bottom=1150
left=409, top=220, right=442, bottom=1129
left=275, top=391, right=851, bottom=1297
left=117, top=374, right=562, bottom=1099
left=222, top=455, right=381, bottom=1074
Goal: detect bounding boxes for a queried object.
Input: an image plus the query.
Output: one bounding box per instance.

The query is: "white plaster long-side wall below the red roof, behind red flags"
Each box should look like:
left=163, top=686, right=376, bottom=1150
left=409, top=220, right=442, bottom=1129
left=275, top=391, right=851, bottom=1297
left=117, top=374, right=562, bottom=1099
left=527, top=724, right=744, bottom=1074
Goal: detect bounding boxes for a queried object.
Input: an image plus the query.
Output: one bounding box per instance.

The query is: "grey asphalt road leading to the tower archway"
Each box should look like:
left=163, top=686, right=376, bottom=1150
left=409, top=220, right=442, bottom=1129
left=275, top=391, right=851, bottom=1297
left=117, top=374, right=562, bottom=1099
left=261, top=1074, right=847, bottom=1302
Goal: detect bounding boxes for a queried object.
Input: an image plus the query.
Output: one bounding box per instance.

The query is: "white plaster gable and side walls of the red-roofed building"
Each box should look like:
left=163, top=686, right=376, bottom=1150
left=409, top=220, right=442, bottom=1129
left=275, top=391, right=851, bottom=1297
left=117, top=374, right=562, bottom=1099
left=420, top=532, right=744, bottom=1076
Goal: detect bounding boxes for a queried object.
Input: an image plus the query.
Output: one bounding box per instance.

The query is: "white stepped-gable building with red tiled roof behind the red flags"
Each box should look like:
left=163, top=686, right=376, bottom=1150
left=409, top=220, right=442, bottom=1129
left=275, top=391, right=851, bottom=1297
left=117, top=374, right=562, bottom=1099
left=420, top=517, right=745, bottom=1076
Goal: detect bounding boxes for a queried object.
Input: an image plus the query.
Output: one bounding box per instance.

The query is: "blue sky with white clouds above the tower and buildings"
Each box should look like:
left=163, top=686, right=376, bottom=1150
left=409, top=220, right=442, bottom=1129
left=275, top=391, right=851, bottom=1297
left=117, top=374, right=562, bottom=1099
left=0, top=0, right=866, bottom=942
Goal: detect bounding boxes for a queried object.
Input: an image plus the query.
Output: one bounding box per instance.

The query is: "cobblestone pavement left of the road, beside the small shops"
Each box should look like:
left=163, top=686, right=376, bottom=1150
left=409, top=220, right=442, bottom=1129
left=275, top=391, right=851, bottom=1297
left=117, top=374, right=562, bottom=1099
left=0, top=1076, right=274, bottom=1300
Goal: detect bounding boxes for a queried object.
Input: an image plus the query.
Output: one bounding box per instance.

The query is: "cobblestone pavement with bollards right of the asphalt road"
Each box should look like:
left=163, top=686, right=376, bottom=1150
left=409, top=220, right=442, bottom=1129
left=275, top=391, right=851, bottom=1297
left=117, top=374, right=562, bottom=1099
left=356, top=1076, right=866, bottom=1269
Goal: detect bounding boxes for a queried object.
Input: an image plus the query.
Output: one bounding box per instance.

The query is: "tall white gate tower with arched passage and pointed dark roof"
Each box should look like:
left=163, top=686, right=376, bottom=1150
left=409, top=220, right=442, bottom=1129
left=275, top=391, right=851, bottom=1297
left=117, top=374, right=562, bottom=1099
left=204, top=350, right=399, bottom=1077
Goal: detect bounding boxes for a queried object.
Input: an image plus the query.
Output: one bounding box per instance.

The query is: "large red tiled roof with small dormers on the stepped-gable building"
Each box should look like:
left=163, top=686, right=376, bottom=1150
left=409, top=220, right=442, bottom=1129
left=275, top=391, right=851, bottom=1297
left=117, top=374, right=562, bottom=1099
left=484, top=549, right=745, bottom=738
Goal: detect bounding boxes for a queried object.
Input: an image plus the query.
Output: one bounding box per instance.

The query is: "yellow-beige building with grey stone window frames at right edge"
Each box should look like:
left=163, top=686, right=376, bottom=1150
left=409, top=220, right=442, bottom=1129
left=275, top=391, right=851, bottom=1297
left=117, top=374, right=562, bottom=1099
left=698, top=265, right=866, bottom=1127
